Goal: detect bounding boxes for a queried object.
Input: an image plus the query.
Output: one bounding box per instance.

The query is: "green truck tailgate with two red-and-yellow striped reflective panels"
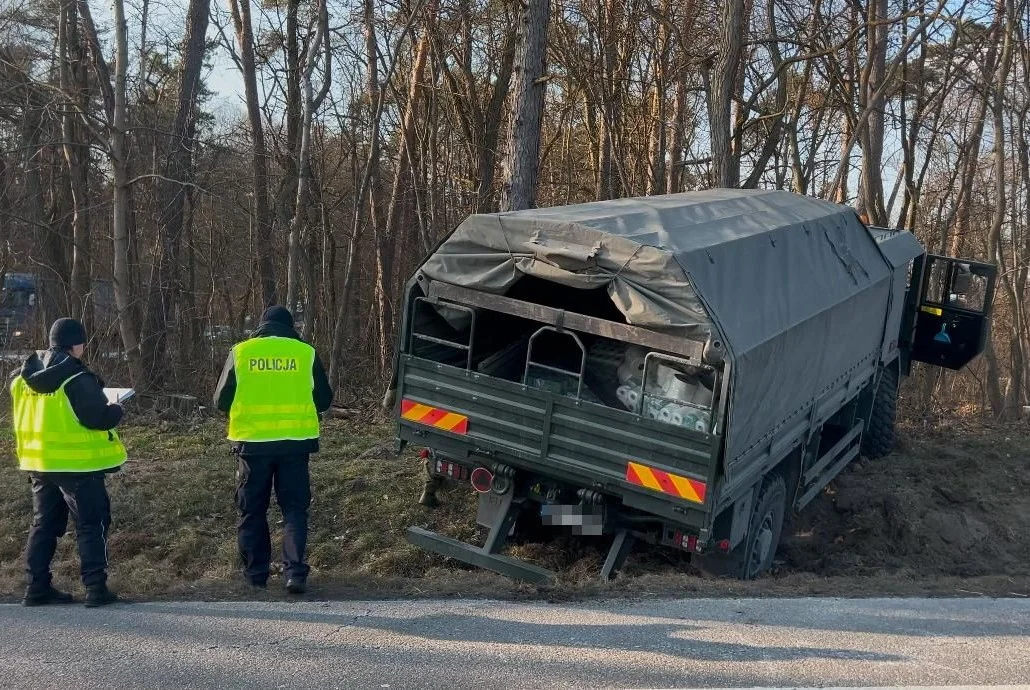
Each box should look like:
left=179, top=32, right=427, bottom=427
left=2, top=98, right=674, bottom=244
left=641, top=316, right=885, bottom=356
left=400, top=355, right=719, bottom=528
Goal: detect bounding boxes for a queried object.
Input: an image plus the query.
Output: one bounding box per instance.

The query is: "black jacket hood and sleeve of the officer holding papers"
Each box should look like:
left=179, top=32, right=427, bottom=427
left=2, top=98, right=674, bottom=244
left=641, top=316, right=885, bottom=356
left=14, top=349, right=123, bottom=432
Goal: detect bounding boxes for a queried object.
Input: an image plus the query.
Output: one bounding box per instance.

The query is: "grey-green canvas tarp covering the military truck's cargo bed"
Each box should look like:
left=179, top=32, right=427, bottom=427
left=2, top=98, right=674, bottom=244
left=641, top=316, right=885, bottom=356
left=421, top=189, right=918, bottom=475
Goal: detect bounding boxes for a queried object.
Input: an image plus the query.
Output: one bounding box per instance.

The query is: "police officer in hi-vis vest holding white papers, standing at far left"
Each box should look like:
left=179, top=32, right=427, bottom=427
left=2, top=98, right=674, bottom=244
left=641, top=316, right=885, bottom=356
left=10, top=318, right=126, bottom=608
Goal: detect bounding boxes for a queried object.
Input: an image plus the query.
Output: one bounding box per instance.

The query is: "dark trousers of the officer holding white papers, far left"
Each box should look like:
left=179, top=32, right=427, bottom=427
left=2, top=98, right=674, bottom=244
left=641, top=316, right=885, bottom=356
left=25, top=472, right=111, bottom=588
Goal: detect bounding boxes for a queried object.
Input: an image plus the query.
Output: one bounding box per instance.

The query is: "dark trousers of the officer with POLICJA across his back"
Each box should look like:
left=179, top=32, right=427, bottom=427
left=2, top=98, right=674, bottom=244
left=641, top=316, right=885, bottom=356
left=236, top=453, right=311, bottom=583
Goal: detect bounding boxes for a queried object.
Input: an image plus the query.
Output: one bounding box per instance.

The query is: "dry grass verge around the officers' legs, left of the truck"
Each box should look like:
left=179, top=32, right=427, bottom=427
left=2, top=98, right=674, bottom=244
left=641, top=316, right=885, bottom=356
left=0, top=420, right=492, bottom=598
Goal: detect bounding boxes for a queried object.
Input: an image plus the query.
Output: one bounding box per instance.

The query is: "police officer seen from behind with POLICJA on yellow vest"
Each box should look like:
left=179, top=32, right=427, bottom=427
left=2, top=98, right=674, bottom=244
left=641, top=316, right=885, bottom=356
left=214, top=306, right=333, bottom=594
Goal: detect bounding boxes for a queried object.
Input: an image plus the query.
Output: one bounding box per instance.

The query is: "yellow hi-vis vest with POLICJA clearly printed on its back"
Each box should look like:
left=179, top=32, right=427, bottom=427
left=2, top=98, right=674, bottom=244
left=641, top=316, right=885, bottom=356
left=229, top=337, right=318, bottom=442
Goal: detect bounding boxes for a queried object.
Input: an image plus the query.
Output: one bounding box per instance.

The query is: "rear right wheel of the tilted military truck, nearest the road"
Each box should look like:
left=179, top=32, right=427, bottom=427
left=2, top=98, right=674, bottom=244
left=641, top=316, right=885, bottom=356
left=698, top=475, right=787, bottom=580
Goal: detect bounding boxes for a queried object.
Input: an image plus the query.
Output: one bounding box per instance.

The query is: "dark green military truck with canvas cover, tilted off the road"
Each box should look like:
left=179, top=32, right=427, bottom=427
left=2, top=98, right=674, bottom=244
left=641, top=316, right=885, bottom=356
left=391, top=189, right=996, bottom=583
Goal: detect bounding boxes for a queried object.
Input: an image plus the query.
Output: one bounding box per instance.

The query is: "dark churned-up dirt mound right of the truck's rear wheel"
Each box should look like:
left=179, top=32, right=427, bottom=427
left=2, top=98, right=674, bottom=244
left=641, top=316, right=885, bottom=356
left=780, top=429, right=1030, bottom=577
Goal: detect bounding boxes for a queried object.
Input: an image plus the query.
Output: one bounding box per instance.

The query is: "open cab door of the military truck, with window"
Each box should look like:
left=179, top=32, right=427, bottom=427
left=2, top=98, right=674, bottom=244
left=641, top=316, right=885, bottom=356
left=909, top=254, right=998, bottom=370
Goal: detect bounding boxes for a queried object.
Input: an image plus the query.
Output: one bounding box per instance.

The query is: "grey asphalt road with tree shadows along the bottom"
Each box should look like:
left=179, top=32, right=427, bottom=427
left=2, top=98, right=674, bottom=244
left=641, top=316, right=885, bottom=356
left=0, top=598, right=1030, bottom=690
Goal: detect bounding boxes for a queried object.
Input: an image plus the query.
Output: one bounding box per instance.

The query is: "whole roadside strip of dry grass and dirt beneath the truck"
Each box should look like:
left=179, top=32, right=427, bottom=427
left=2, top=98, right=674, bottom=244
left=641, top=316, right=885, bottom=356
left=0, top=420, right=1030, bottom=600
